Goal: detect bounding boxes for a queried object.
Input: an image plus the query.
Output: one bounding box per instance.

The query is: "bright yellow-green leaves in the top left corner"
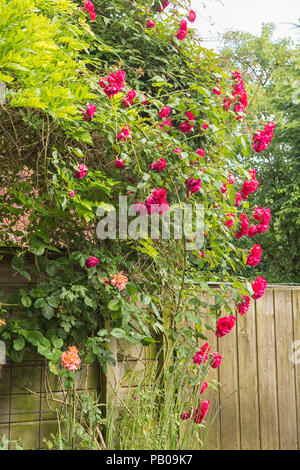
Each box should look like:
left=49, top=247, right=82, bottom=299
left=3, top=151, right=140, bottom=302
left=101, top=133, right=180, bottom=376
left=0, top=0, right=94, bottom=119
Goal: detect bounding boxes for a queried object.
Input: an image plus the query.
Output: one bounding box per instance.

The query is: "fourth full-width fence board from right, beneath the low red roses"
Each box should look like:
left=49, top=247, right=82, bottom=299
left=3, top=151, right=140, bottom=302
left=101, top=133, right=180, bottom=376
left=218, top=302, right=241, bottom=450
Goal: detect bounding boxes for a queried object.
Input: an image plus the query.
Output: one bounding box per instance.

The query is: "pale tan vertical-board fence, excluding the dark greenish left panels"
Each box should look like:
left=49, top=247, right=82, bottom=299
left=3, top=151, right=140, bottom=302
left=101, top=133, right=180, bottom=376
left=108, top=286, right=300, bottom=450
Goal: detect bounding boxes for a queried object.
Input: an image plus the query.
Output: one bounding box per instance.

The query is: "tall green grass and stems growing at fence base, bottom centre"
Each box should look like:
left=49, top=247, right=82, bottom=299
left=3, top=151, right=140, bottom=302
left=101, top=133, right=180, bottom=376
left=105, top=346, right=217, bottom=450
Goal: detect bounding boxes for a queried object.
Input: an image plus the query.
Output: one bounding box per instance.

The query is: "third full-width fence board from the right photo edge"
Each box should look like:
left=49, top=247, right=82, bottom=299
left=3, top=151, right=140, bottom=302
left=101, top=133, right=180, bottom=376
left=237, top=300, right=260, bottom=450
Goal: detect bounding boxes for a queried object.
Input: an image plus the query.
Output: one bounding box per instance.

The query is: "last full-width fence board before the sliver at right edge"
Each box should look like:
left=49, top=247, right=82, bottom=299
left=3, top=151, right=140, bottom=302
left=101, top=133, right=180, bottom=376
left=274, top=289, right=297, bottom=450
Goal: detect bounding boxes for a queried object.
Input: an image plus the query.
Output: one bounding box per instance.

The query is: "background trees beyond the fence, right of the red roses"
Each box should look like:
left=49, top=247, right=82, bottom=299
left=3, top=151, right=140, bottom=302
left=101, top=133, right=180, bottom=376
left=221, top=24, right=300, bottom=283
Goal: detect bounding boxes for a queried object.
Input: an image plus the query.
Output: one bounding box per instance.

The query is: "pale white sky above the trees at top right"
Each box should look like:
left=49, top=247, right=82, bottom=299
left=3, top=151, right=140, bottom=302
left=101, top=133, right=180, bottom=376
left=192, top=0, right=300, bottom=48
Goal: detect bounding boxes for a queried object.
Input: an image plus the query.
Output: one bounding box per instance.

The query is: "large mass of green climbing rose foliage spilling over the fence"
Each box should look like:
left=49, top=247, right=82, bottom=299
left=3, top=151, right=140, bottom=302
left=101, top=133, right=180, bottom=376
left=0, top=0, right=272, bottom=377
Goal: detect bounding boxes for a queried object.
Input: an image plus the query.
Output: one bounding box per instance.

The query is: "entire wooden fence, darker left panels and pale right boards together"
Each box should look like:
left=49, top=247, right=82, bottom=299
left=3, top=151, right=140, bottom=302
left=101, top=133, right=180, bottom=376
left=0, top=258, right=300, bottom=450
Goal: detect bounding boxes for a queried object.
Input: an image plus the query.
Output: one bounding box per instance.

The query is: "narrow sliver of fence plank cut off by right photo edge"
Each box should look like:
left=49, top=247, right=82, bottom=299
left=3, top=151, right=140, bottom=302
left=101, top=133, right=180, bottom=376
left=291, top=290, right=300, bottom=449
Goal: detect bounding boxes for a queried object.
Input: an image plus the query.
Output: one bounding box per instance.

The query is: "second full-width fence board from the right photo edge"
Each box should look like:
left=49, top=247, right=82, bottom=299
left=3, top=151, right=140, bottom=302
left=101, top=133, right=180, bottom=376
left=256, top=289, right=279, bottom=450
